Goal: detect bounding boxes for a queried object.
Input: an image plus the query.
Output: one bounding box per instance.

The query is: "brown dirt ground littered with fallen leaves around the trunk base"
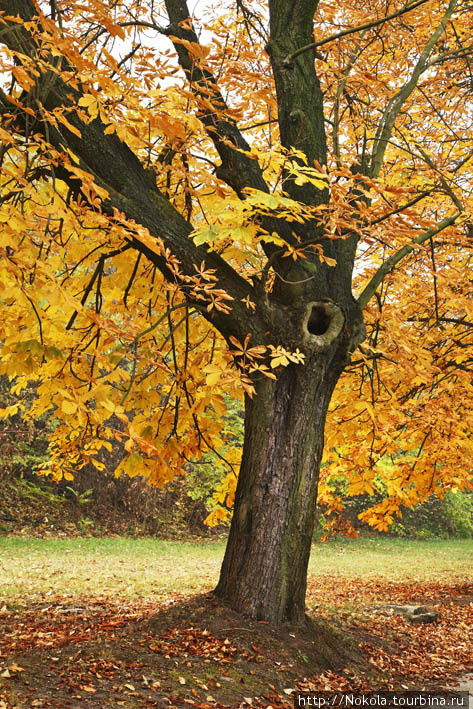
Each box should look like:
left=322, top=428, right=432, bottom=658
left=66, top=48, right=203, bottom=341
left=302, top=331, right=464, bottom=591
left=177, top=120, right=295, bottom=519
left=0, top=577, right=473, bottom=709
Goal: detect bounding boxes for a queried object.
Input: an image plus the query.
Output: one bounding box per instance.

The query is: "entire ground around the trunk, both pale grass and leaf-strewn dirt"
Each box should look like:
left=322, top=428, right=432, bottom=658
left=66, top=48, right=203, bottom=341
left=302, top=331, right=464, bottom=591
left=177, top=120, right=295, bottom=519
left=0, top=537, right=473, bottom=709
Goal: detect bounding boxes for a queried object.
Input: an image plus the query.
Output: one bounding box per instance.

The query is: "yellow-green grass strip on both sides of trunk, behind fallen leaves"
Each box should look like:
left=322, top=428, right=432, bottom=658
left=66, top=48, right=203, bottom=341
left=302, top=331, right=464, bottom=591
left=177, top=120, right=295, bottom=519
left=0, top=537, right=473, bottom=604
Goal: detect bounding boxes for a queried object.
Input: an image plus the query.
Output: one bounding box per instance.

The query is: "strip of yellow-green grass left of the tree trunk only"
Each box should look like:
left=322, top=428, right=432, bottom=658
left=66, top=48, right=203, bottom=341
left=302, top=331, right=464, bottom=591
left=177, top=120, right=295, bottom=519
left=0, top=537, right=224, bottom=599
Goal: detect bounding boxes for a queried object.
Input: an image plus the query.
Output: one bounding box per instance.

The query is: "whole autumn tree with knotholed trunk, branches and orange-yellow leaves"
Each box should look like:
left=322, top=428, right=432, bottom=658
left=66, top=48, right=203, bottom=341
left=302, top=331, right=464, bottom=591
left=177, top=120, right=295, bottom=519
left=0, top=0, right=473, bottom=623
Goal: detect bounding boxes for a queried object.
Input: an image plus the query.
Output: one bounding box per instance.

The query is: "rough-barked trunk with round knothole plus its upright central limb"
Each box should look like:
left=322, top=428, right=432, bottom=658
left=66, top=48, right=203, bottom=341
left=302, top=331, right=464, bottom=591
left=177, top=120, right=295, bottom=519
left=215, top=0, right=364, bottom=624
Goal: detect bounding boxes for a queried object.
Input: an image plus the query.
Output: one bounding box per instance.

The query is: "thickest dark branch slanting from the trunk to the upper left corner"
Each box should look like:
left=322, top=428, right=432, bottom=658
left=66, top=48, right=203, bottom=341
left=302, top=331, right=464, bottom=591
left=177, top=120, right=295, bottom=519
left=0, top=0, right=257, bottom=338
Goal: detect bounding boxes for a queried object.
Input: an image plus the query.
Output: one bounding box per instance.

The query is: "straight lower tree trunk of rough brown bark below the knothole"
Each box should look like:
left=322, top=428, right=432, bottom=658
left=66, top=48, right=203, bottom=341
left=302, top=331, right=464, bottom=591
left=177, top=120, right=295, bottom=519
left=215, top=352, right=343, bottom=624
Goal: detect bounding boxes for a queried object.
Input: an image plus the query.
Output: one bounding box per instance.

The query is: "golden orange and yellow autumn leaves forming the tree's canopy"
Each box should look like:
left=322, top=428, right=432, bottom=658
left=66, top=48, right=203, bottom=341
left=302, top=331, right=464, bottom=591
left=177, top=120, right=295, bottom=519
left=0, top=0, right=473, bottom=530
